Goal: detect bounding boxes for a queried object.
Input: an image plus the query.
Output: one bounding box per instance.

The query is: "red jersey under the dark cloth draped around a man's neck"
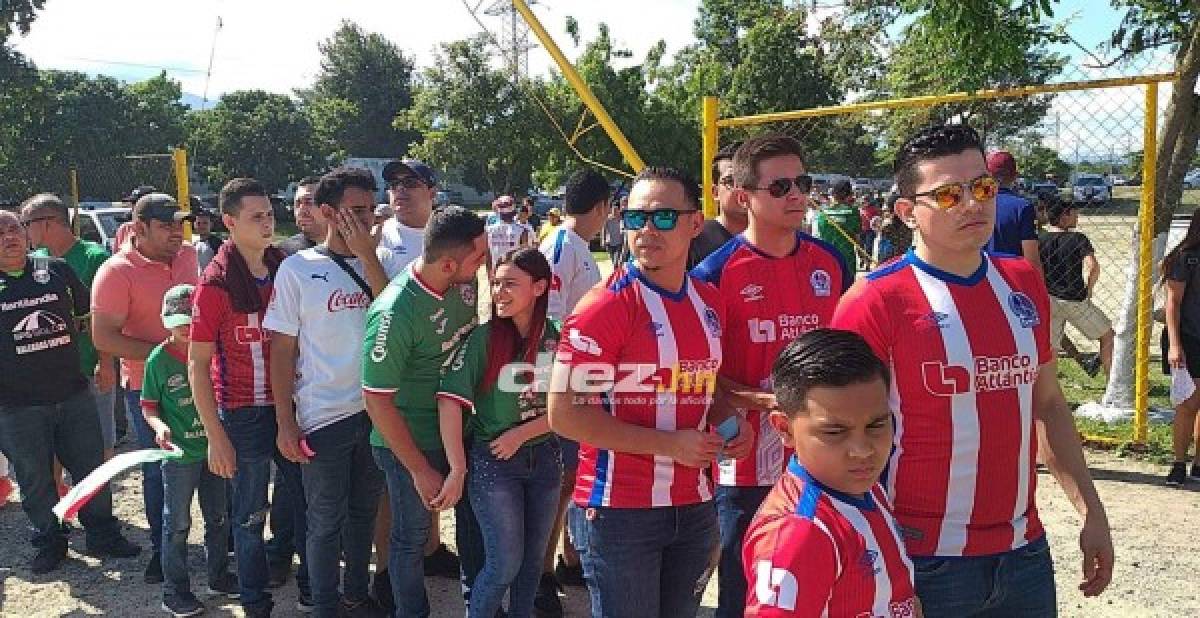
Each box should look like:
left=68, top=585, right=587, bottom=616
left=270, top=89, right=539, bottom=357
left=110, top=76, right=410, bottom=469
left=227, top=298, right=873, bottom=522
left=192, top=282, right=275, bottom=410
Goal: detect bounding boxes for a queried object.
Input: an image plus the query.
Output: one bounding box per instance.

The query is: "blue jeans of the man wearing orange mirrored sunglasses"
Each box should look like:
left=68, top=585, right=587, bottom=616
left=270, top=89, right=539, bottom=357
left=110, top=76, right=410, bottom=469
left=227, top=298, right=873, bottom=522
left=912, top=535, right=1058, bottom=618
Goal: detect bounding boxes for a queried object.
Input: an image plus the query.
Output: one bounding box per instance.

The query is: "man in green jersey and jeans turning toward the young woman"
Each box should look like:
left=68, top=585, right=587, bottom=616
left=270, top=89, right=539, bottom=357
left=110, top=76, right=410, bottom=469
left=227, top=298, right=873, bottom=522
left=362, top=206, right=487, bottom=617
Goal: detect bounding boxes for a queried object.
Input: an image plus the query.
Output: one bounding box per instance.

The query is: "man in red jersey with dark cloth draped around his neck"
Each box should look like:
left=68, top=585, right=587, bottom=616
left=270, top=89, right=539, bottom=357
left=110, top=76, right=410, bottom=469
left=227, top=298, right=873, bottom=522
left=188, top=178, right=297, bottom=616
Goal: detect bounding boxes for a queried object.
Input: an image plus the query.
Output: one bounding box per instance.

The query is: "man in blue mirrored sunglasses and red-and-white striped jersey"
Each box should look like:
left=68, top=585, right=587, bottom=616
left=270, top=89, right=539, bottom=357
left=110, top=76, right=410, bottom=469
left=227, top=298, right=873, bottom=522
left=548, top=167, right=750, bottom=617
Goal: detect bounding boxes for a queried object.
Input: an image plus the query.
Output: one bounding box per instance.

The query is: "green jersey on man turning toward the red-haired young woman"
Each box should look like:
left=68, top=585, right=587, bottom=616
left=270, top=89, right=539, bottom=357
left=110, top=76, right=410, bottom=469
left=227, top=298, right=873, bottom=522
left=362, top=263, right=478, bottom=450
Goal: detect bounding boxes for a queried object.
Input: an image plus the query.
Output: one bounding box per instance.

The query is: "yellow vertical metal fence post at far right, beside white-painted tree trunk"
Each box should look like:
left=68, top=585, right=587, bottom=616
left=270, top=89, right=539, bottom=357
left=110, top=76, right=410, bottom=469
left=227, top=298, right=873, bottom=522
left=1133, top=82, right=1158, bottom=444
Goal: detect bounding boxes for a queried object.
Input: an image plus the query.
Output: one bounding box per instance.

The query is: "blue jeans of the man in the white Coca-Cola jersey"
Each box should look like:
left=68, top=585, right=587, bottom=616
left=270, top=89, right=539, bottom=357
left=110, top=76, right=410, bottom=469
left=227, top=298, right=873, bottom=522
left=301, top=412, right=383, bottom=617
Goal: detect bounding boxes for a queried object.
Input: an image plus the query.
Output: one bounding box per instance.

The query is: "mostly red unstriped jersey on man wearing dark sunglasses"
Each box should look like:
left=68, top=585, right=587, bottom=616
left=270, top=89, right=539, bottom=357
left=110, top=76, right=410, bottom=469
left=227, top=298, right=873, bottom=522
left=692, top=234, right=853, bottom=487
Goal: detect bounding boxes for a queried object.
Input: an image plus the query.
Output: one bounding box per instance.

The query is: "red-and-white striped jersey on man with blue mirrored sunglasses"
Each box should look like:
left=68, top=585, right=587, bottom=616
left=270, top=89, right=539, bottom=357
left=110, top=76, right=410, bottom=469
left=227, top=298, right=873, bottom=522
left=556, top=265, right=725, bottom=509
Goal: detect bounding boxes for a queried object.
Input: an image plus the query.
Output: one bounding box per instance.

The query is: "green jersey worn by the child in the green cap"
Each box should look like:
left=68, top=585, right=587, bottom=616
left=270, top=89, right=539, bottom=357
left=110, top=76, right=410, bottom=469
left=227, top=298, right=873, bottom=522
left=142, top=343, right=209, bottom=463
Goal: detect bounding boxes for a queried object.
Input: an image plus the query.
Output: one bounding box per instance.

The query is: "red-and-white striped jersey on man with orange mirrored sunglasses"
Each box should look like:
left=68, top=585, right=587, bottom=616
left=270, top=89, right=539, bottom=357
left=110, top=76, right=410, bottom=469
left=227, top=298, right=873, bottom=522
left=833, top=251, right=1054, bottom=557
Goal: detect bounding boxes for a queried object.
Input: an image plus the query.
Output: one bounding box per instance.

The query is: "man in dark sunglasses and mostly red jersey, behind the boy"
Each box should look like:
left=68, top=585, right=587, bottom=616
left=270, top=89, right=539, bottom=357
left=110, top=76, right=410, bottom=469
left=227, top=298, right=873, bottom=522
left=692, top=136, right=851, bottom=618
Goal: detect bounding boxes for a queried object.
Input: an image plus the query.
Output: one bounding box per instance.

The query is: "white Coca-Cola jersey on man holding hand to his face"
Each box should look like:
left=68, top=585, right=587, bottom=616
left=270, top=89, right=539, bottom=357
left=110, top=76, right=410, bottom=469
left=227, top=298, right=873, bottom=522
left=263, top=247, right=408, bottom=433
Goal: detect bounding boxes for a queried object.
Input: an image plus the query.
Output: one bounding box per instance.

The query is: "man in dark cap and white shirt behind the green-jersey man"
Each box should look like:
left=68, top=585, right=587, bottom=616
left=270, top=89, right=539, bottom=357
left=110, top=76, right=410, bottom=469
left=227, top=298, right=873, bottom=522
left=379, top=158, right=438, bottom=270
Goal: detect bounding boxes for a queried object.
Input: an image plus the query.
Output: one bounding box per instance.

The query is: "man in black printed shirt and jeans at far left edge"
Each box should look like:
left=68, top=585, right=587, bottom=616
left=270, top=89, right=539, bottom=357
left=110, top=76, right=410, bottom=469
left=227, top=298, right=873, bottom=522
left=0, top=211, right=140, bottom=574
